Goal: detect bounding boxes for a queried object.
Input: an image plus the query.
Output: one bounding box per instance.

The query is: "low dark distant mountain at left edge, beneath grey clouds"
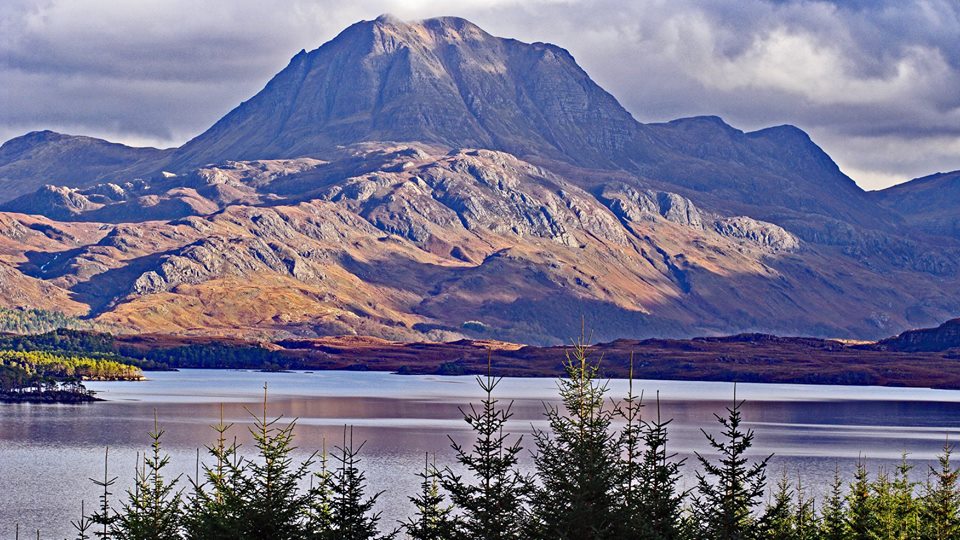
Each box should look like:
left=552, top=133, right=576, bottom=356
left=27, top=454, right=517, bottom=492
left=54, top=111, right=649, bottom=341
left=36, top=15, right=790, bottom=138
left=0, top=131, right=167, bottom=201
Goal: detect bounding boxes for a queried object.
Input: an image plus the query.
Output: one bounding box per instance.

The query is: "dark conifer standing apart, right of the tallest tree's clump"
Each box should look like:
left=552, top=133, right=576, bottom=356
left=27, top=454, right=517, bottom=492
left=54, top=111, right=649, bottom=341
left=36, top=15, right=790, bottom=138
left=693, top=387, right=772, bottom=540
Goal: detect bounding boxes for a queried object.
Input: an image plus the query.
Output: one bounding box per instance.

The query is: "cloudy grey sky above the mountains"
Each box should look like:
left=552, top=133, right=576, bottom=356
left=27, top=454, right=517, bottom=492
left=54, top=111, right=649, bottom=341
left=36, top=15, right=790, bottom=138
left=0, top=0, right=960, bottom=189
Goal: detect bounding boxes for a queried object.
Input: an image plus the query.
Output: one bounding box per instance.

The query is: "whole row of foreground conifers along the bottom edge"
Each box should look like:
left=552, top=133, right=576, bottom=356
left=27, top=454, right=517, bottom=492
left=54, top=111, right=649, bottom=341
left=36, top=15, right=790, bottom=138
left=28, top=343, right=960, bottom=540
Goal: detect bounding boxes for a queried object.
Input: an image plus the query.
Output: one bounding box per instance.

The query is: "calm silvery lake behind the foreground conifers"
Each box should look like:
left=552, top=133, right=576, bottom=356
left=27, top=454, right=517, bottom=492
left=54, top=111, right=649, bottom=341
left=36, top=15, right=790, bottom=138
left=0, top=370, right=960, bottom=538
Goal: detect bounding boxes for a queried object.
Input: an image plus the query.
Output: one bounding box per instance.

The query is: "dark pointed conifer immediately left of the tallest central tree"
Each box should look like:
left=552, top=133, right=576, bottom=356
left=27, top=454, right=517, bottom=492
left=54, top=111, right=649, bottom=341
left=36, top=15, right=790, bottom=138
left=441, top=364, right=530, bottom=540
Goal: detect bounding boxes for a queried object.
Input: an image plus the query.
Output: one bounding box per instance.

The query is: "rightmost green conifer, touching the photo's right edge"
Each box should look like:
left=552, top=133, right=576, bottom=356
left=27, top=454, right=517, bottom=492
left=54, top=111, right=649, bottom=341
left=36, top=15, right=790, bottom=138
left=920, top=442, right=960, bottom=540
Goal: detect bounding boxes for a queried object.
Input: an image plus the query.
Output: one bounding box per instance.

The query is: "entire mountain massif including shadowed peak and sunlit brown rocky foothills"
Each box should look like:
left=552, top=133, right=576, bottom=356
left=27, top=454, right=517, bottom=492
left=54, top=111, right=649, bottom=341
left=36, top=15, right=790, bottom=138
left=0, top=17, right=960, bottom=343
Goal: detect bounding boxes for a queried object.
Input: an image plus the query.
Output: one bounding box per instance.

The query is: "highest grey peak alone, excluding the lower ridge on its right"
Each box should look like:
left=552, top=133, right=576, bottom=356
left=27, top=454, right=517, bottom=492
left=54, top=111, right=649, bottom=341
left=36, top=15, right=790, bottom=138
left=171, top=15, right=643, bottom=169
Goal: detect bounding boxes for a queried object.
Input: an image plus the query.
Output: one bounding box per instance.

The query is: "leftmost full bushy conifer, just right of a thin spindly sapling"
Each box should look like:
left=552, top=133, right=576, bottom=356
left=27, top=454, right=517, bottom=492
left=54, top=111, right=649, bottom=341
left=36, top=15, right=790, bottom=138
left=113, top=414, right=181, bottom=540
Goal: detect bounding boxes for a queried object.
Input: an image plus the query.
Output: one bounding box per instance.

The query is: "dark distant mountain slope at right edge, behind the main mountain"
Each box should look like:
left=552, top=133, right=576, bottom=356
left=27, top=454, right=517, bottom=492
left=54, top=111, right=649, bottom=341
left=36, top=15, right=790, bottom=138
left=871, top=171, right=960, bottom=239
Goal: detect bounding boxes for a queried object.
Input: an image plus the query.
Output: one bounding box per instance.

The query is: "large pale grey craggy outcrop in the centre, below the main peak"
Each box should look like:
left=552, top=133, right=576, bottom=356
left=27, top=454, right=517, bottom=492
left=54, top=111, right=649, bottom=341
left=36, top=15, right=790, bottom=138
left=324, top=150, right=626, bottom=247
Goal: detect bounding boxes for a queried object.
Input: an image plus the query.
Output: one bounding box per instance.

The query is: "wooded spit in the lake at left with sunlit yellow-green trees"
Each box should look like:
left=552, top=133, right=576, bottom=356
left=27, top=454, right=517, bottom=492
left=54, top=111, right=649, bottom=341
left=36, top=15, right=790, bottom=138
left=0, top=350, right=143, bottom=403
